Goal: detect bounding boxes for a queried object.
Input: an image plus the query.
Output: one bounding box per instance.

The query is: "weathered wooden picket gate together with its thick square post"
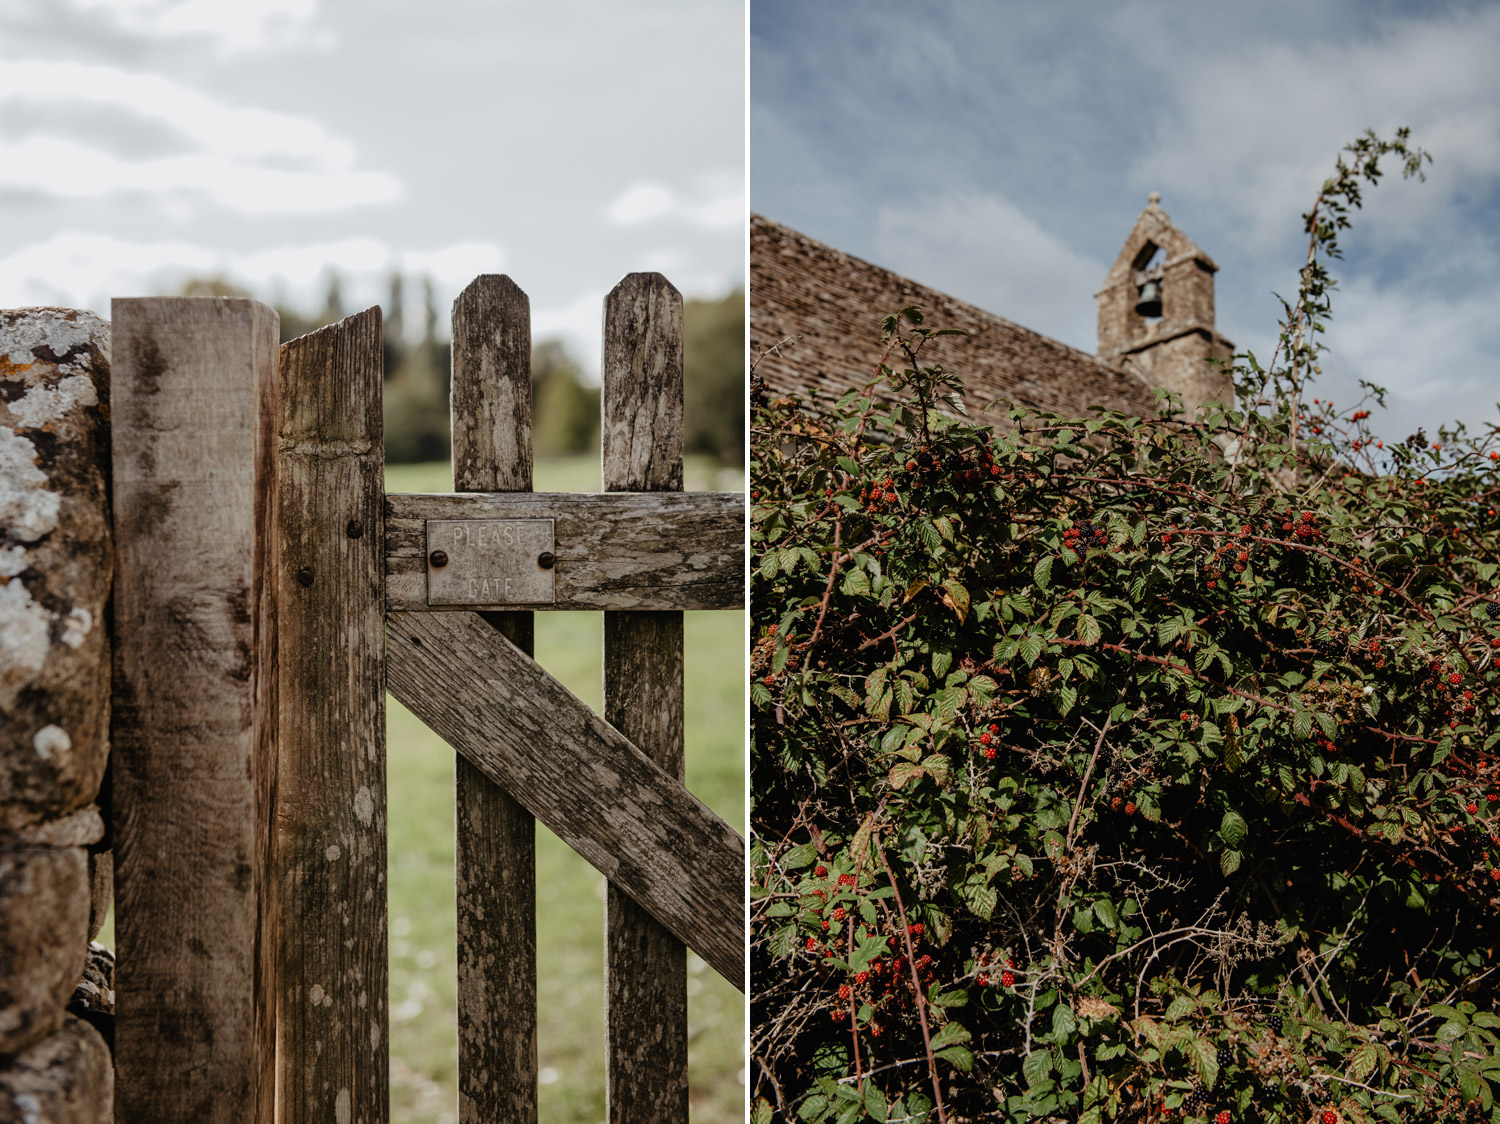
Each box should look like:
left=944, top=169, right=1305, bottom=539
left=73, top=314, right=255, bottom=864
left=111, top=273, right=746, bottom=1124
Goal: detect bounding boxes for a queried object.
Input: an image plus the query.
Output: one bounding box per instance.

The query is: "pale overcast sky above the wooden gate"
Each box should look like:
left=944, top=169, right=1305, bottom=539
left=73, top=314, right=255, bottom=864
left=0, top=0, right=746, bottom=369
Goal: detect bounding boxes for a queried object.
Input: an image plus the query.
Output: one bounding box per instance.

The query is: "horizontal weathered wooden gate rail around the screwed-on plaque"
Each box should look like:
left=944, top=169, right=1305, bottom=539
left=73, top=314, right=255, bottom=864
left=386, top=492, right=746, bottom=612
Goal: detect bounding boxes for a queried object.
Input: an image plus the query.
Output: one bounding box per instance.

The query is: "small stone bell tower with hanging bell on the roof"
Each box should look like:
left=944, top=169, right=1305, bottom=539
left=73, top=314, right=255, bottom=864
left=1095, top=192, right=1235, bottom=417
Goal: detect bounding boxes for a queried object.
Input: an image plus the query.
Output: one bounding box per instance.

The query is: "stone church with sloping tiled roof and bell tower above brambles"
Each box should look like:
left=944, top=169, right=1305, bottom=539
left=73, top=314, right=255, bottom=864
left=750, top=192, right=1233, bottom=423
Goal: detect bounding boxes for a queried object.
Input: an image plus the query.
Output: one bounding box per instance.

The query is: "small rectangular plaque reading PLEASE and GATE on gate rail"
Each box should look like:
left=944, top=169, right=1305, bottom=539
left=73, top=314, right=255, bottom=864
left=428, top=519, right=557, bottom=605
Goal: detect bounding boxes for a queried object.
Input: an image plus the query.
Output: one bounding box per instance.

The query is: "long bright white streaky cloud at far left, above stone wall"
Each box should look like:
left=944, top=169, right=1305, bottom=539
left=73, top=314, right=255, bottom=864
left=0, top=59, right=401, bottom=215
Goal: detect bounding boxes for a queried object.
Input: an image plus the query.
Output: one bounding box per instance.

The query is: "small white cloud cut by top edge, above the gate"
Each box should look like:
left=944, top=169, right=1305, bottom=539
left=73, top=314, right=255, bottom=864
left=71, top=0, right=333, bottom=54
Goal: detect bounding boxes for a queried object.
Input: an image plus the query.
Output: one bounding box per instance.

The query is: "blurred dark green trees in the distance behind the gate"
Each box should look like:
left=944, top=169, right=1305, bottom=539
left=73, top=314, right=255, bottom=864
left=180, top=273, right=746, bottom=465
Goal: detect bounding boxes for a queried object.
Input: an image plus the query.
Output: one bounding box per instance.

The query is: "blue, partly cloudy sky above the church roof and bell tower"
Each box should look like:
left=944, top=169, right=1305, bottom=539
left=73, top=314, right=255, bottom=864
left=750, top=0, right=1500, bottom=447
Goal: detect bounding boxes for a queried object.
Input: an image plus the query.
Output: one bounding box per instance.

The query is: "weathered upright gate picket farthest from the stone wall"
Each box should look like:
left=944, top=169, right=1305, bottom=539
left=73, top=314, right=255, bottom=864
left=600, top=273, right=687, bottom=1124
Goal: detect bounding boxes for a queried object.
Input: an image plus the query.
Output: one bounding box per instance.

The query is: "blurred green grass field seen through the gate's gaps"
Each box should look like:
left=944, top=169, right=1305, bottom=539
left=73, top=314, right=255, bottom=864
left=101, top=456, right=746, bottom=1124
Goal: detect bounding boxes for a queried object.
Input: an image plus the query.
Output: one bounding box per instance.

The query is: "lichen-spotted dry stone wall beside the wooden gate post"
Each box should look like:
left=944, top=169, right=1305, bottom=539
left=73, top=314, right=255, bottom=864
left=0, top=308, right=114, bottom=1124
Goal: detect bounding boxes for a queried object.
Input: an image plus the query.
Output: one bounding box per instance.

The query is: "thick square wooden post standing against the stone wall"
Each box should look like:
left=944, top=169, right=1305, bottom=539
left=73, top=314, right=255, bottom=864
left=111, top=297, right=278, bottom=1124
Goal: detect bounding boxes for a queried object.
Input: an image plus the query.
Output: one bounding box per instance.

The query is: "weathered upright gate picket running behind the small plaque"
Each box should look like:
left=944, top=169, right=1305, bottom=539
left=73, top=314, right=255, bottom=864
left=447, top=275, right=537, bottom=1124
